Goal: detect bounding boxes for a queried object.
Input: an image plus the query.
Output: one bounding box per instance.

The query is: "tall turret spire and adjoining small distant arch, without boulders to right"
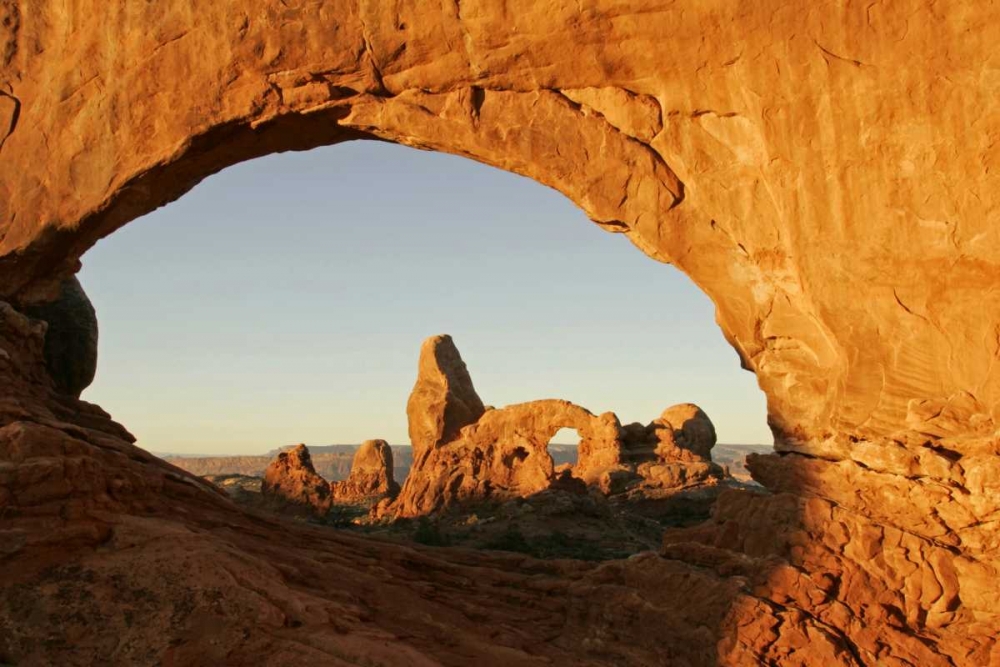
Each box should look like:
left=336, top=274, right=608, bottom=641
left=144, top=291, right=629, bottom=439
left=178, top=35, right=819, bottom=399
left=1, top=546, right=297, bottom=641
left=390, top=335, right=621, bottom=517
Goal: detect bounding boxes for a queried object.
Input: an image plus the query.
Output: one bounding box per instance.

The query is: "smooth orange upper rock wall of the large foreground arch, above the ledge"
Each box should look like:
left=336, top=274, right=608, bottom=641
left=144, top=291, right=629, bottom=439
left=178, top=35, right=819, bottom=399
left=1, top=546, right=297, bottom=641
left=7, top=0, right=1000, bottom=448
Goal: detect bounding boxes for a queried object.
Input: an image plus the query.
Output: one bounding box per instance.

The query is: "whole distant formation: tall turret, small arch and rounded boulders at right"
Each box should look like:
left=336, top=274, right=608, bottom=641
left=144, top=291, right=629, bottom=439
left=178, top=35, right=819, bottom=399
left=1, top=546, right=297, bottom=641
left=386, top=336, right=724, bottom=517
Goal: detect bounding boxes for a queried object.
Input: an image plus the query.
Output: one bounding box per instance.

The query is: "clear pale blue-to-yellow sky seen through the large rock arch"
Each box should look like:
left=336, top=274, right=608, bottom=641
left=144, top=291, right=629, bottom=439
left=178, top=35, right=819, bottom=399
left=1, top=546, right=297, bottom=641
left=79, top=141, right=772, bottom=454
